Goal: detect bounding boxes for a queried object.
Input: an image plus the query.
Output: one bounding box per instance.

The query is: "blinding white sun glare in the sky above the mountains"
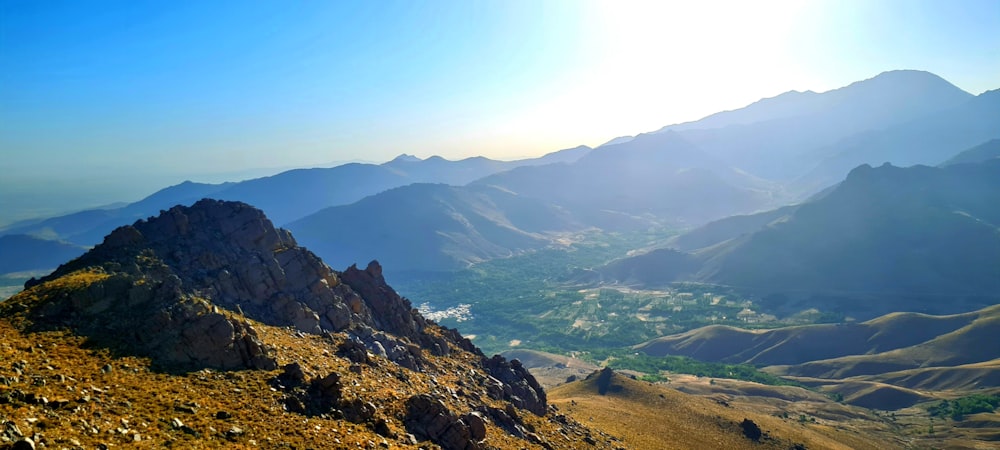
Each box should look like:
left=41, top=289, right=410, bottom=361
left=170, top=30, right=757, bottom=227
left=495, top=1, right=806, bottom=150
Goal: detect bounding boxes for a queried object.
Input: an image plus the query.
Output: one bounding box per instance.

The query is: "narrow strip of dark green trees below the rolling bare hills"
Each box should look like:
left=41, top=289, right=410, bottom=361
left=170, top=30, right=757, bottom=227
left=591, top=351, right=805, bottom=388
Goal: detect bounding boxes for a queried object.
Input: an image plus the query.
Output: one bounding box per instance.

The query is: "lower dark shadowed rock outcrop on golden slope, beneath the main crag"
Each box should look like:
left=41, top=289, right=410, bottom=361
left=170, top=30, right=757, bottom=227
left=32, top=262, right=277, bottom=370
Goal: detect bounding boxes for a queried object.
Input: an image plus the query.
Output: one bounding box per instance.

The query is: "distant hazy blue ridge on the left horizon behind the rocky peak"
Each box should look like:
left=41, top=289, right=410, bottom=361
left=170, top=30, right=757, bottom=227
left=0, top=146, right=590, bottom=246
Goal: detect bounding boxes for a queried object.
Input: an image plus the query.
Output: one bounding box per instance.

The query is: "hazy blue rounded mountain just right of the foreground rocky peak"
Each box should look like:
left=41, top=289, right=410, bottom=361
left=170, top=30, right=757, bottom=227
left=288, top=184, right=583, bottom=271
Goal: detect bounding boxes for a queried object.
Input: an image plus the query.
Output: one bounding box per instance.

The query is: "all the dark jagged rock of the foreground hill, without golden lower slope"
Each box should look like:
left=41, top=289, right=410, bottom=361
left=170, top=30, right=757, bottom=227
left=11, top=199, right=547, bottom=415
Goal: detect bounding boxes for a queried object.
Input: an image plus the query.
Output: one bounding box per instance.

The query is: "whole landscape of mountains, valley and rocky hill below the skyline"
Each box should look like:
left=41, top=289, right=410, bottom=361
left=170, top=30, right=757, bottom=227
left=0, top=70, right=1000, bottom=450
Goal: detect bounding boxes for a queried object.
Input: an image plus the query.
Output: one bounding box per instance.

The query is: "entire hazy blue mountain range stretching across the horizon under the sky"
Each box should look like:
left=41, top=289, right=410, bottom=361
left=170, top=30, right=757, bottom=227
left=0, top=70, right=1000, bottom=278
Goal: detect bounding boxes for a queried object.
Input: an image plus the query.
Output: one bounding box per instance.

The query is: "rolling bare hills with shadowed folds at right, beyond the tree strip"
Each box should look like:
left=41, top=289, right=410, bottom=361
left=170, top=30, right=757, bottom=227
left=636, top=306, right=1000, bottom=372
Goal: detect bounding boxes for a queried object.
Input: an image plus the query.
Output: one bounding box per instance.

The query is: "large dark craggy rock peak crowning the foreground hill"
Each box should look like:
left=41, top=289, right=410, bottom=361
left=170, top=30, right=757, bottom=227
left=29, top=199, right=360, bottom=333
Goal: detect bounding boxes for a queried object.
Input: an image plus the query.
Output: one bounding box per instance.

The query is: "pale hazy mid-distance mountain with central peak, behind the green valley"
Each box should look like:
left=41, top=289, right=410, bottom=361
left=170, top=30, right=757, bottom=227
left=474, top=132, right=772, bottom=229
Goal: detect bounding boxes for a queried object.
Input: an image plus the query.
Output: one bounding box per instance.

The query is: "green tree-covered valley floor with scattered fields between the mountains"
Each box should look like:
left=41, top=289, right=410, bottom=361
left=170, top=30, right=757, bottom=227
left=389, top=230, right=813, bottom=354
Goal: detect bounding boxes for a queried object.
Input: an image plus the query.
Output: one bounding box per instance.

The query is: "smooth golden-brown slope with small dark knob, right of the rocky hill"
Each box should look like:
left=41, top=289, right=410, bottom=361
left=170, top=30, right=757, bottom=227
left=549, top=374, right=905, bottom=450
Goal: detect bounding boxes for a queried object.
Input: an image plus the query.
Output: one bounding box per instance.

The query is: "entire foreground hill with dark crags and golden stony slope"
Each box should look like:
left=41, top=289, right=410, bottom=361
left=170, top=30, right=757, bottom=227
left=0, top=200, right=612, bottom=450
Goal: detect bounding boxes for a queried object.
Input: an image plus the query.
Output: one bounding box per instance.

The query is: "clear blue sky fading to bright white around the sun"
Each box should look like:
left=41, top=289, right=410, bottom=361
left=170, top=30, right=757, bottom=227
left=0, top=0, right=1000, bottom=218
